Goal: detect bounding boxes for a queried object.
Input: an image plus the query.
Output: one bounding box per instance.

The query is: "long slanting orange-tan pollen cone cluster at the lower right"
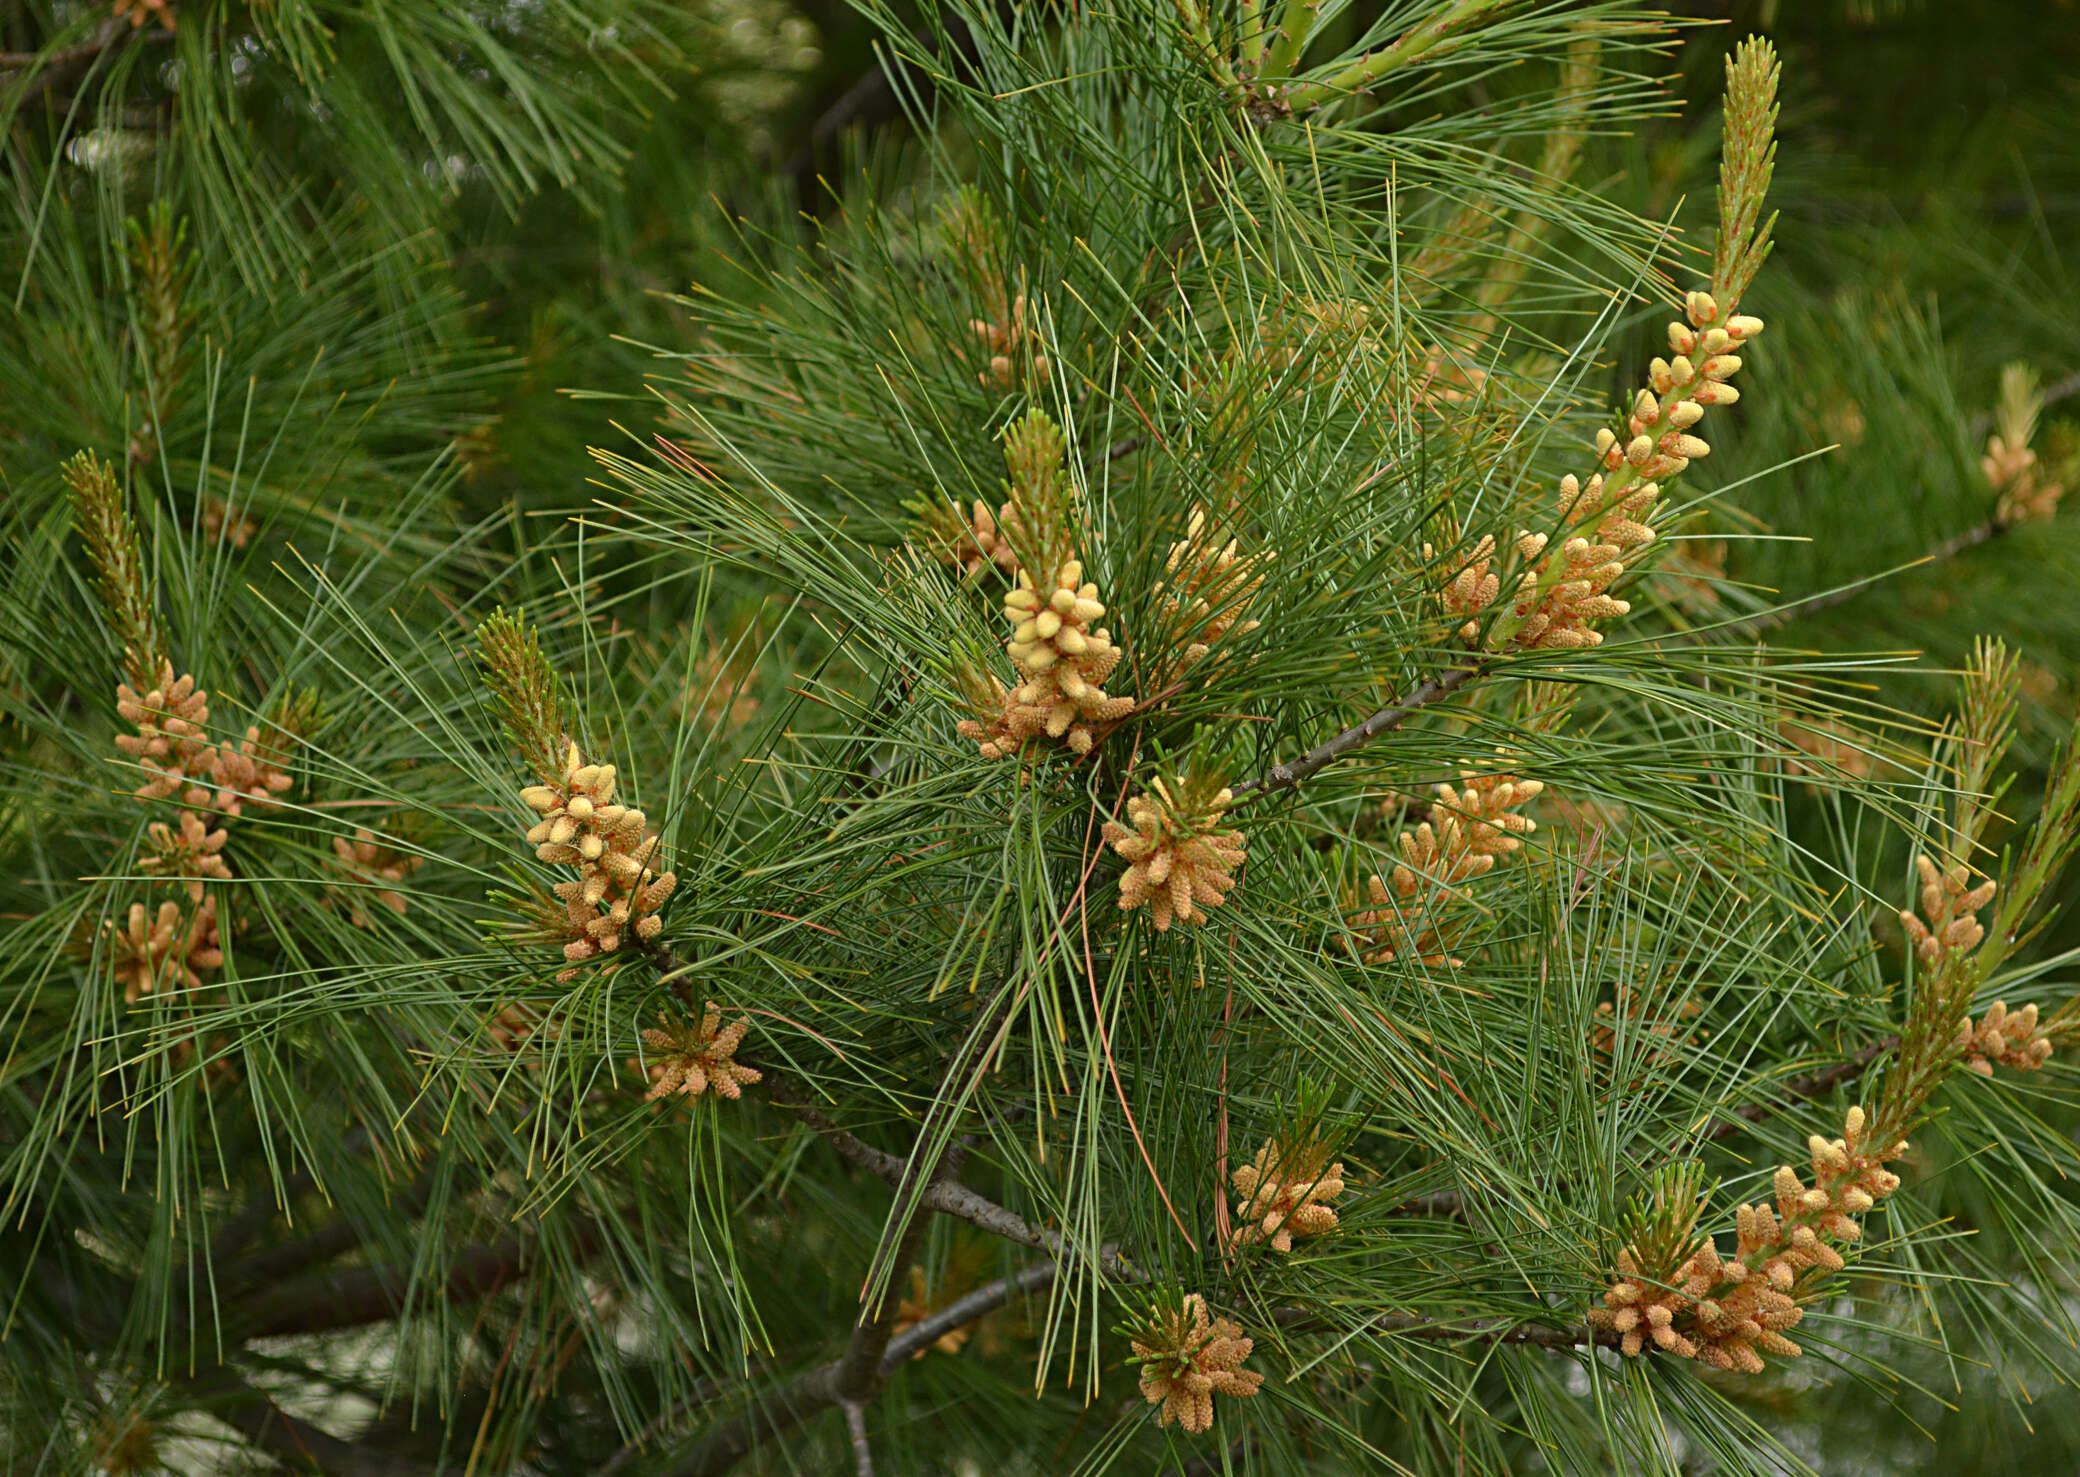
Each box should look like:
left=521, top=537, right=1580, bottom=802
left=1589, top=1107, right=1907, bottom=1373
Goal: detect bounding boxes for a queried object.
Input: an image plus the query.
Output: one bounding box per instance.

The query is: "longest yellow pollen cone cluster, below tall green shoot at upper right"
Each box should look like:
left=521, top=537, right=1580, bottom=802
left=1431, top=291, right=1762, bottom=649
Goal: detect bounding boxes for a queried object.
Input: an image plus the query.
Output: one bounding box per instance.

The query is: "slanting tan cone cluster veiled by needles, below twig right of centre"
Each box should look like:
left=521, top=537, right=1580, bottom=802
left=1346, top=772, right=1545, bottom=969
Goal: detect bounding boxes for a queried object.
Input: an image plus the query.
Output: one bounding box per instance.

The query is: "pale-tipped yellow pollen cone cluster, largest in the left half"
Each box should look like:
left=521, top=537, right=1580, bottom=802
left=520, top=745, right=678, bottom=965
